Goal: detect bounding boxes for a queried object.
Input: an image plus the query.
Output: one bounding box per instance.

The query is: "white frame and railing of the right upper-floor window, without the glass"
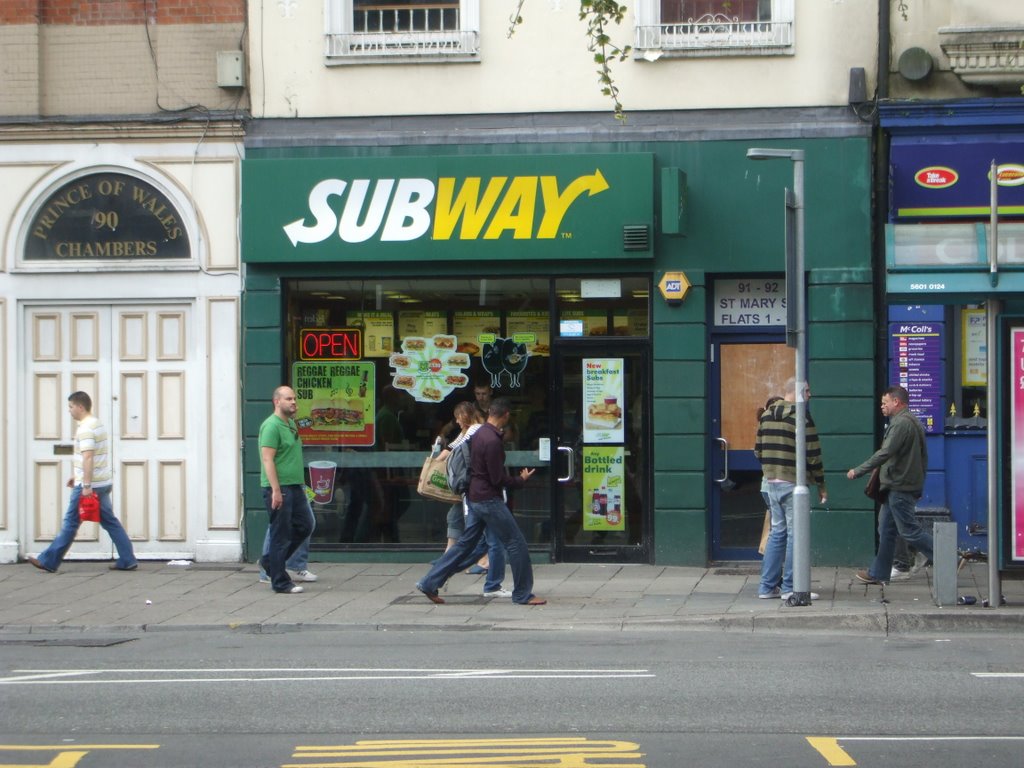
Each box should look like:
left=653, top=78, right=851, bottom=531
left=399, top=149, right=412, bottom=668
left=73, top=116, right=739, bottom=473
left=633, top=0, right=796, bottom=61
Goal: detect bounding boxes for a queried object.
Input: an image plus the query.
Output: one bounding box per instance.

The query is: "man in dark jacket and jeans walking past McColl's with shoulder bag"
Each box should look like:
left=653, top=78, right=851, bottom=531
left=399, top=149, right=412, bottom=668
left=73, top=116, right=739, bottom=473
left=846, top=387, right=932, bottom=584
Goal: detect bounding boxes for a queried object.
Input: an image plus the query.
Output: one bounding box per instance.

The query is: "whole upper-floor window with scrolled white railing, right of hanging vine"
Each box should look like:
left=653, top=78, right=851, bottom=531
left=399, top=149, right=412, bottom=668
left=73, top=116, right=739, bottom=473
left=635, top=0, right=794, bottom=58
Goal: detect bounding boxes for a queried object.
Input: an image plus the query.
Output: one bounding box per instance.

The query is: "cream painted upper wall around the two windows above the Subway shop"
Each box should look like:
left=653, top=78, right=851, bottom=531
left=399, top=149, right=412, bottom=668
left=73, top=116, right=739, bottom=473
left=249, top=0, right=877, bottom=118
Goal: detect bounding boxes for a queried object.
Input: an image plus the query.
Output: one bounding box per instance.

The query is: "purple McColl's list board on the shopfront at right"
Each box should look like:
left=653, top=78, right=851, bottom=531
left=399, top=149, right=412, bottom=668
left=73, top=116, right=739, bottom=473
left=889, top=323, right=944, bottom=434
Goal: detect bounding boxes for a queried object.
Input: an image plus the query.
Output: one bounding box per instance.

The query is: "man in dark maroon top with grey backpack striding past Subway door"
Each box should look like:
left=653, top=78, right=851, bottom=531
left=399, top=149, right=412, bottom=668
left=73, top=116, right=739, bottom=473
left=416, top=397, right=547, bottom=605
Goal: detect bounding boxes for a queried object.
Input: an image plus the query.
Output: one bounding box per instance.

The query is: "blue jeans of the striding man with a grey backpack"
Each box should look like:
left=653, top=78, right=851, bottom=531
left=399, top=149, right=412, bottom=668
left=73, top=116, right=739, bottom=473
left=416, top=499, right=534, bottom=603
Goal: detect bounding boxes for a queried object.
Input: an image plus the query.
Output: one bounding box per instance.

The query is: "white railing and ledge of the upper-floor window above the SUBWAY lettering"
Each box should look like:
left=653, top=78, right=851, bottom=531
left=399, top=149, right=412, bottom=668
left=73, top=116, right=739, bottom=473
left=327, top=2, right=479, bottom=58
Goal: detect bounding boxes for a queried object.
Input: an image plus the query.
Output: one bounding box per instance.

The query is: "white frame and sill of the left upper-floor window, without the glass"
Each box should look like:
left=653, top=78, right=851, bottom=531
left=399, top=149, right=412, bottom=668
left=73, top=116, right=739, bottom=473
left=324, top=0, right=480, bottom=66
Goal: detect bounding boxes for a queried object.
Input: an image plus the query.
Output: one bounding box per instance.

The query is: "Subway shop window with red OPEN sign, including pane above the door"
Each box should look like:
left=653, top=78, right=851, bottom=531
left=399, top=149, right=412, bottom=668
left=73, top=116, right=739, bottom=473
left=286, top=278, right=649, bottom=550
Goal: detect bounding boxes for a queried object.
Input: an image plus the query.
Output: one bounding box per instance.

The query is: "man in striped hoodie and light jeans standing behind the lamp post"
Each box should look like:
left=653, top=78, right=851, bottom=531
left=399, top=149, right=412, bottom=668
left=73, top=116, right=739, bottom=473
left=754, top=378, right=828, bottom=600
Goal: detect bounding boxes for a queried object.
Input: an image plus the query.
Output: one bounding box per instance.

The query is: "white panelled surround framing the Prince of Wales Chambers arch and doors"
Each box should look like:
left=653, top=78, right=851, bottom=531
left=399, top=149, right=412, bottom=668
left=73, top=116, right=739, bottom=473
left=0, top=138, right=242, bottom=562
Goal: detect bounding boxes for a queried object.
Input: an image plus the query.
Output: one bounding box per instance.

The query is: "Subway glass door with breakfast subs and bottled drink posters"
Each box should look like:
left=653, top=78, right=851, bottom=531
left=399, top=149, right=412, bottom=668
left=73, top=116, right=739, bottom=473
left=551, top=346, right=650, bottom=562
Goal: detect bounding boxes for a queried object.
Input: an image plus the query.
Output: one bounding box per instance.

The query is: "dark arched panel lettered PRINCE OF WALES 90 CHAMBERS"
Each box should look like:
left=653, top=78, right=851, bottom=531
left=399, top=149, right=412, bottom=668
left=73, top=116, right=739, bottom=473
left=25, top=173, right=190, bottom=261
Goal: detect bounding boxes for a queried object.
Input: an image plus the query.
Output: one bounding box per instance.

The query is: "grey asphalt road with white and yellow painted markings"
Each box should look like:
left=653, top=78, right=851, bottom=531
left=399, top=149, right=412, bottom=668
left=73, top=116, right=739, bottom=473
left=0, top=631, right=1024, bottom=768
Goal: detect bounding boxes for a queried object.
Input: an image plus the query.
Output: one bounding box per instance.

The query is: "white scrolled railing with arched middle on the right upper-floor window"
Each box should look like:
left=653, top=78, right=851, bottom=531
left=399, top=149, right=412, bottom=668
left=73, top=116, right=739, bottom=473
left=636, top=13, right=793, bottom=51
